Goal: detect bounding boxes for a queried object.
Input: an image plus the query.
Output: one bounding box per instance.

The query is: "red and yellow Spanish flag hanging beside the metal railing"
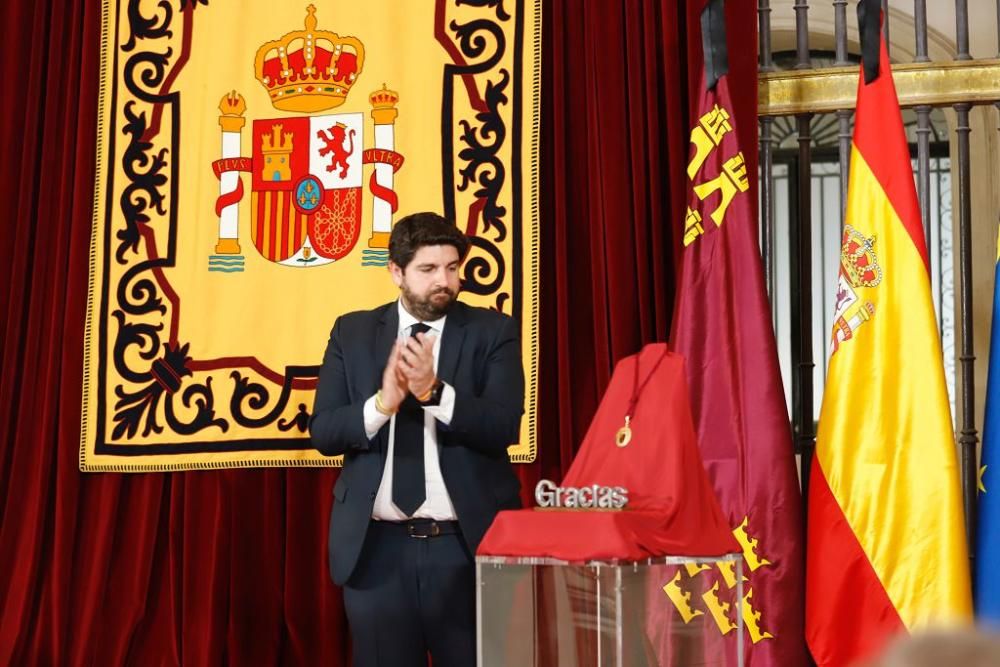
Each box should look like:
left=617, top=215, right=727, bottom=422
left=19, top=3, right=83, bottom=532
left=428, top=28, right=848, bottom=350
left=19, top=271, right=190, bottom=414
left=806, top=23, right=971, bottom=667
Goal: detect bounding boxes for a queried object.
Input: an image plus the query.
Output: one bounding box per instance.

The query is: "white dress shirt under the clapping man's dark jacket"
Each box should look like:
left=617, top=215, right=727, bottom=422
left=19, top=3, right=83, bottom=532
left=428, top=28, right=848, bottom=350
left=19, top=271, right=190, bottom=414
left=364, top=301, right=457, bottom=521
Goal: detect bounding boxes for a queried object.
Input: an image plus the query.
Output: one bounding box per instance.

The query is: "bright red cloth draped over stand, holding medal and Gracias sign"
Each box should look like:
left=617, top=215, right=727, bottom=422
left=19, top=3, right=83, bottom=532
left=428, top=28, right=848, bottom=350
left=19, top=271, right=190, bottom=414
left=477, top=343, right=740, bottom=562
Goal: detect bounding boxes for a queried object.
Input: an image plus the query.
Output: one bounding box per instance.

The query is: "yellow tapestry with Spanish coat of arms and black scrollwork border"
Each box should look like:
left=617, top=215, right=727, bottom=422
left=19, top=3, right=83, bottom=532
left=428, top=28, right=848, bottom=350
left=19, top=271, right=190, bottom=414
left=80, top=0, right=541, bottom=472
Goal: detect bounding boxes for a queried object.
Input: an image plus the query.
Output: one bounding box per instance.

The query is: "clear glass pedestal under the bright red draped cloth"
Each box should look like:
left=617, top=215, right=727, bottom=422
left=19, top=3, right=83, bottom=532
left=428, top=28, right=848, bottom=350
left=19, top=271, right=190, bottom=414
left=476, top=554, right=744, bottom=667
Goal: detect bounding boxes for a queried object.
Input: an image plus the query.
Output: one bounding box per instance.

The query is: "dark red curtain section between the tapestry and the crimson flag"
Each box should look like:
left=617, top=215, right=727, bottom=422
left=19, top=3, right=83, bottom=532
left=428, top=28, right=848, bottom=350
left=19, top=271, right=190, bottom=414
left=538, top=0, right=702, bottom=480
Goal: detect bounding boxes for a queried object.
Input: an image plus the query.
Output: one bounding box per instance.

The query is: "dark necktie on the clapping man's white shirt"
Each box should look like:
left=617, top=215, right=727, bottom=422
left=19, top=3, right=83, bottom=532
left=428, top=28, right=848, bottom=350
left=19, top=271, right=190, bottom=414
left=392, top=322, right=431, bottom=516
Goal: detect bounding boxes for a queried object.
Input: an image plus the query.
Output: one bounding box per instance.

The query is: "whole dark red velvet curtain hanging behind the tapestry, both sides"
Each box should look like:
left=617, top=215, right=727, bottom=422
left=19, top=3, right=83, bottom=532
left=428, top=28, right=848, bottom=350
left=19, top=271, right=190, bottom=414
left=0, top=0, right=712, bottom=665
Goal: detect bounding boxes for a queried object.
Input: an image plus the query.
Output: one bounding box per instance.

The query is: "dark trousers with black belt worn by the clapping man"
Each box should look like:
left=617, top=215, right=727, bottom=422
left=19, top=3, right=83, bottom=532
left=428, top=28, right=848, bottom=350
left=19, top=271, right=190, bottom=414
left=343, top=521, right=476, bottom=667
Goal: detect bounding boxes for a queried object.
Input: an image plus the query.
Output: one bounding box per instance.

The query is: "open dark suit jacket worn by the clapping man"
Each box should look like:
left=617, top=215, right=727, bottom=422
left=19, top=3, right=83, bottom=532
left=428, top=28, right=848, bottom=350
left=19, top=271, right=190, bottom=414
left=309, top=301, right=524, bottom=584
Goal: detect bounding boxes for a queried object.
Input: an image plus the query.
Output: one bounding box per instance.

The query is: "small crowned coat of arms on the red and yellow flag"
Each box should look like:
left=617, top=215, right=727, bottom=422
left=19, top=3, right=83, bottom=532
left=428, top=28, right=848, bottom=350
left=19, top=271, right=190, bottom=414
left=830, top=225, right=882, bottom=353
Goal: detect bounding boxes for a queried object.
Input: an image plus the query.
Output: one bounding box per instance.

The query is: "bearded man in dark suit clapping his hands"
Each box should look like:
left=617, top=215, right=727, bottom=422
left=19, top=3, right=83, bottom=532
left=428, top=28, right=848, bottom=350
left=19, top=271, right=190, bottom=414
left=309, top=213, right=524, bottom=667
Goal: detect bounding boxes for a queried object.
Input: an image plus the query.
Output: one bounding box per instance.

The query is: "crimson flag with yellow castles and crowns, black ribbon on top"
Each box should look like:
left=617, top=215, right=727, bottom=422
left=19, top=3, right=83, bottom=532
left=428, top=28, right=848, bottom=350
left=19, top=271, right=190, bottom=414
left=660, top=0, right=806, bottom=667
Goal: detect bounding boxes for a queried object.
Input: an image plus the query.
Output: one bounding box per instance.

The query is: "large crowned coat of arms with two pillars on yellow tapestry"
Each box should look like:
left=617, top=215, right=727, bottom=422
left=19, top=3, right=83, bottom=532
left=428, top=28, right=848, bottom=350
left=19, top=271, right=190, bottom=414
left=208, top=5, right=403, bottom=272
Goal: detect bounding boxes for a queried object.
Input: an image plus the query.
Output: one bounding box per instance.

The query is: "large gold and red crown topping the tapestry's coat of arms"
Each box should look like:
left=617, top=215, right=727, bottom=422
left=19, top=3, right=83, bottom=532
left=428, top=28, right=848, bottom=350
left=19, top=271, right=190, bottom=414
left=254, top=5, right=365, bottom=113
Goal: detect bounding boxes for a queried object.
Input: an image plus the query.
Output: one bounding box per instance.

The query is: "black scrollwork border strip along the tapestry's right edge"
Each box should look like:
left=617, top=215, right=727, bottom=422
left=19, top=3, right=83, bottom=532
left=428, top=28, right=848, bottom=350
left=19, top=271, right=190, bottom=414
left=439, top=0, right=541, bottom=462
